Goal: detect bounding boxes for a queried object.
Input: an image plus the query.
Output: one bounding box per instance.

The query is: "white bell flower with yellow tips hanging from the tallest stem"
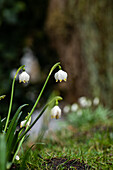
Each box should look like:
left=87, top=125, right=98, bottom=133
left=54, top=70, right=67, bottom=82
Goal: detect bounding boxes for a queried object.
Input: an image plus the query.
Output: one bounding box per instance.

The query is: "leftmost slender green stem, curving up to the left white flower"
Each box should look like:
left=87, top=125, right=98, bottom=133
left=4, top=65, right=25, bottom=132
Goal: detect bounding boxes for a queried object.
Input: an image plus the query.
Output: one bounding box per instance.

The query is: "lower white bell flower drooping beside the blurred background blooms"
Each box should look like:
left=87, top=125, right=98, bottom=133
left=51, top=106, right=61, bottom=119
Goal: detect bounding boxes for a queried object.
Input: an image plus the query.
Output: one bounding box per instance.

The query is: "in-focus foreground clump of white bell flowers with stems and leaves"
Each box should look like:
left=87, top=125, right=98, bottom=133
left=0, top=62, right=67, bottom=169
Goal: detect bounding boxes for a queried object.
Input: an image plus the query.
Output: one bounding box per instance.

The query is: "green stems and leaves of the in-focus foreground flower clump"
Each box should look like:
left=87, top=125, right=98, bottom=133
left=0, top=62, right=62, bottom=170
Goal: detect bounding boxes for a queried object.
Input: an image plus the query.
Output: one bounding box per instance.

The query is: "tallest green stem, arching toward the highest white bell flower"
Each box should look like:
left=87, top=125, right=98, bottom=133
left=26, top=62, right=60, bottom=124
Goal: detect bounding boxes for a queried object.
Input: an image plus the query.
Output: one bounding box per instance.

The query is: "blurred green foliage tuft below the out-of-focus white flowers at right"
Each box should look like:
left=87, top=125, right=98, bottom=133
left=67, top=105, right=113, bottom=127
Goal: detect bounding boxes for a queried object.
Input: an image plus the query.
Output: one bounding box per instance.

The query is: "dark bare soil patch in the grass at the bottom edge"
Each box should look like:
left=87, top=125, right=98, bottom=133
left=44, top=158, right=93, bottom=170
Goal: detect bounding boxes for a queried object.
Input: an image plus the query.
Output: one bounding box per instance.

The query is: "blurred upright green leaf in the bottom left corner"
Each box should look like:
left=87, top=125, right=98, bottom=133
left=0, top=134, right=6, bottom=170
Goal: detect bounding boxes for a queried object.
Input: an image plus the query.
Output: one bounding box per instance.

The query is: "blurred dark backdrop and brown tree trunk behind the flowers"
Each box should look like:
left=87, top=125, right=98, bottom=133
left=0, top=0, right=113, bottom=117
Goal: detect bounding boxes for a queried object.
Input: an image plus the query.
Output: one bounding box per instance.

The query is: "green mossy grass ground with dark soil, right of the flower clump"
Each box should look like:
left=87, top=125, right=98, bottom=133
left=14, top=106, right=113, bottom=170
